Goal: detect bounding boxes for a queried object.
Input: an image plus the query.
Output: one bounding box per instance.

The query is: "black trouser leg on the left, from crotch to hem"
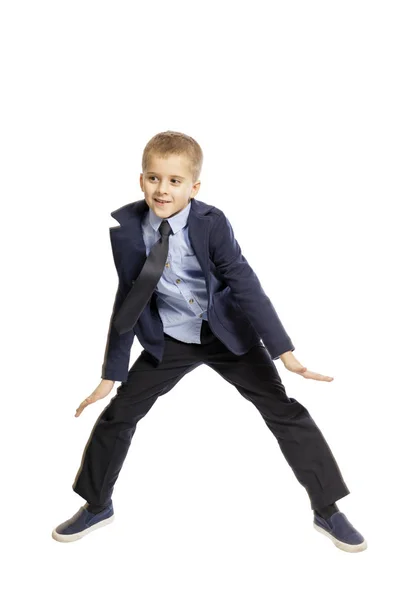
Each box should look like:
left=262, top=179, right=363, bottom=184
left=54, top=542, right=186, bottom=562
left=72, top=340, right=201, bottom=506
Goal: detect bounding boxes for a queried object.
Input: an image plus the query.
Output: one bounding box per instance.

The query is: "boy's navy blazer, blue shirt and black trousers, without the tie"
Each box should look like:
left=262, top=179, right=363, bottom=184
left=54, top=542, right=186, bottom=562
left=72, top=198, right=350, bottom=509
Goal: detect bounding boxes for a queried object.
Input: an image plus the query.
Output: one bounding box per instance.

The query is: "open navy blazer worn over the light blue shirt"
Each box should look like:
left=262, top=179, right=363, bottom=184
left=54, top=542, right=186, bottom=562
left=101, top=198, right=295, bottom=382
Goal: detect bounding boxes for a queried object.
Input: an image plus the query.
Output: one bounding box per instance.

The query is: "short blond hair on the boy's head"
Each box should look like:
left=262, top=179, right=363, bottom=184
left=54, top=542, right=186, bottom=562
left=142, top=130, right=203, bottom=181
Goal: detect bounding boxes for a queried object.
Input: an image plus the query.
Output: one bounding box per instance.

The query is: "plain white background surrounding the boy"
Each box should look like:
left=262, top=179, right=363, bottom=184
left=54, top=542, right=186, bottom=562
left=0, top=0, right=400, bottom=600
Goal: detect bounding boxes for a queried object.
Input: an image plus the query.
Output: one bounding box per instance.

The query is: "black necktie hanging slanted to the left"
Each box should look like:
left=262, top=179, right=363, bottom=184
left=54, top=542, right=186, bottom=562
left=114, top=219, right=172, bottom=335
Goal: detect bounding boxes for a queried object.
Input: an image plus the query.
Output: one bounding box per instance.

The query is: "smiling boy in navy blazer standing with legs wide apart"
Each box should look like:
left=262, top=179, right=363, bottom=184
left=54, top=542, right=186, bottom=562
left=52, top=131, right=367, bottom=552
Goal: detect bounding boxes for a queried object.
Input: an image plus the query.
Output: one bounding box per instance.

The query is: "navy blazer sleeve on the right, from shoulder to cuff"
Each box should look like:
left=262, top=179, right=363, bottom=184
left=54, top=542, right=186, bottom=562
left=210, top=211, right=295, bottom=360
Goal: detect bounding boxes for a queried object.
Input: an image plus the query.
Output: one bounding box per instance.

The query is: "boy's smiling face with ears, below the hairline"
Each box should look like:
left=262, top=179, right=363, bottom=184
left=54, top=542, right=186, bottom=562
left=140, top=154, right=200, bottom=219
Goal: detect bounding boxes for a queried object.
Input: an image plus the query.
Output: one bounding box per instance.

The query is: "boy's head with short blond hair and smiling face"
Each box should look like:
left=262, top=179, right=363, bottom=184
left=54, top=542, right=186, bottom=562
left=140, top=131, right=203, bottom=219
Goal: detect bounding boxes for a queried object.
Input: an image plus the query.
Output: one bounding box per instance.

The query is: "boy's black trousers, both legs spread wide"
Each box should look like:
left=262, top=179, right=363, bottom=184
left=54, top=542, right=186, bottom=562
left=72, top=320, right=350, bottom=510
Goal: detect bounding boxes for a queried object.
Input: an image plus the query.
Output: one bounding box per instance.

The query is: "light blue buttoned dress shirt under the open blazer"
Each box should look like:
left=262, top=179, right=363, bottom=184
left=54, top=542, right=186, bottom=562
left=142, top=202, right=208, bottom=344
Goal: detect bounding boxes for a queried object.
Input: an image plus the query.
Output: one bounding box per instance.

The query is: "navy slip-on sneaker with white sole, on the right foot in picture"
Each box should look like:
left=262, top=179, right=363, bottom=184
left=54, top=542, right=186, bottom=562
left=313, top=510, right=367, bottom=552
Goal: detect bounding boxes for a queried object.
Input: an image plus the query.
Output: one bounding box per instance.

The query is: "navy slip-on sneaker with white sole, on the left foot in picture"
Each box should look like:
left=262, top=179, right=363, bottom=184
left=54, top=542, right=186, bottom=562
left=51, top=500, right=114, bottom=542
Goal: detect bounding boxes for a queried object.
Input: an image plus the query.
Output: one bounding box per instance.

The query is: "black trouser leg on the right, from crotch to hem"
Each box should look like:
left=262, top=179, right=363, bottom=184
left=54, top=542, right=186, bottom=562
left=206, top=344, right=350, bottom=509
